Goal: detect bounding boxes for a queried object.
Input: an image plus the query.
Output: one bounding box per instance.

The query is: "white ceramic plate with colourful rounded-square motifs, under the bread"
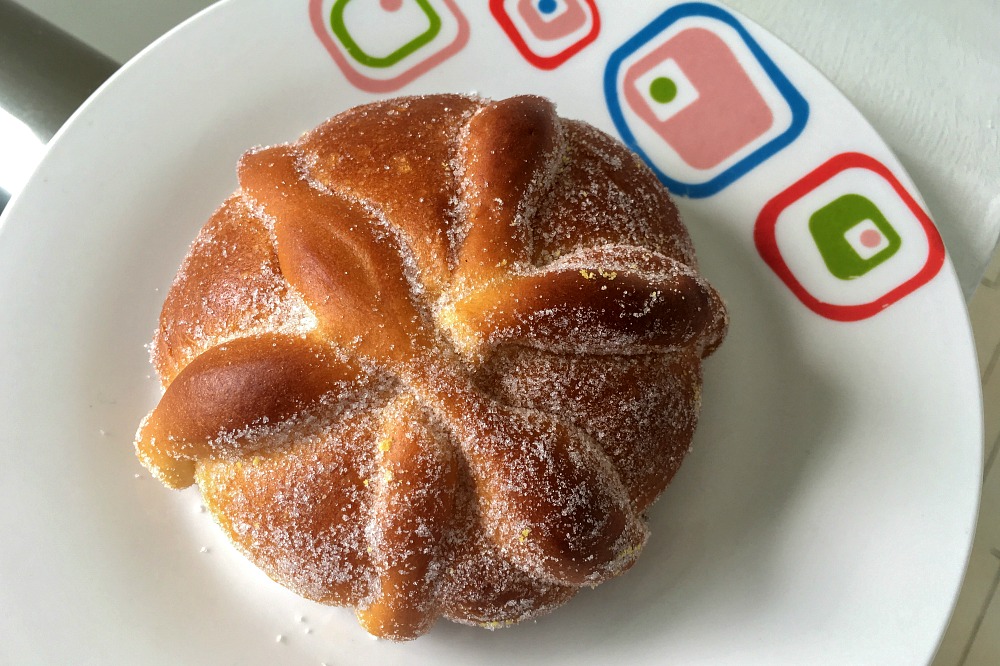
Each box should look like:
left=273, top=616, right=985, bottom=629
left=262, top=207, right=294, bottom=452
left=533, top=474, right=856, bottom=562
left=0, top=0, right=981, bottom=664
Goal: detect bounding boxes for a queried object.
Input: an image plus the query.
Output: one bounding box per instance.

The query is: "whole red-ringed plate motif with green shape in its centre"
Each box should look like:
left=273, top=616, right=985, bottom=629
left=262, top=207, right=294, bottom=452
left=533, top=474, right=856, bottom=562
left=754, top=153, right=945, bottom=321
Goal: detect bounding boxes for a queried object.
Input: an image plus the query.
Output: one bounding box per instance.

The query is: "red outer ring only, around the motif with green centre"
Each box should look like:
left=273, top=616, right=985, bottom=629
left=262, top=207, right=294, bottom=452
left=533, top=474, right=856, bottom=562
left=753, top=153, right=945, bottom=321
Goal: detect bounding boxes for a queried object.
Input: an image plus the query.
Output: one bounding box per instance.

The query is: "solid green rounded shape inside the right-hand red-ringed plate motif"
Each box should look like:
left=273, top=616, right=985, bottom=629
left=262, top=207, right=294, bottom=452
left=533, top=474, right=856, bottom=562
left=809, top=194, right=903, bottom=280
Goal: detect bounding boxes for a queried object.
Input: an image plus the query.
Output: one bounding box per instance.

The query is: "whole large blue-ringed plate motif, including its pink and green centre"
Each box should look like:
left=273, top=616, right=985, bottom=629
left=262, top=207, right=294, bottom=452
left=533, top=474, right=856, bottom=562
left=604, top=2, right=809, bottom=197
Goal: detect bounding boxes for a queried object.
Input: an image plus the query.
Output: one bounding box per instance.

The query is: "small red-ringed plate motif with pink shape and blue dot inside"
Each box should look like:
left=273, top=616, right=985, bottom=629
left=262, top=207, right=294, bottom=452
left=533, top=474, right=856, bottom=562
left=490, top=0, right=601, bottom=69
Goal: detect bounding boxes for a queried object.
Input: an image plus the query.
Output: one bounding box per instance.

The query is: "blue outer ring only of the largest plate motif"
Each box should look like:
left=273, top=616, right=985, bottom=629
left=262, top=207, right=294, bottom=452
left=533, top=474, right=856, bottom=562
left=604, top=2, right=809, bottom=199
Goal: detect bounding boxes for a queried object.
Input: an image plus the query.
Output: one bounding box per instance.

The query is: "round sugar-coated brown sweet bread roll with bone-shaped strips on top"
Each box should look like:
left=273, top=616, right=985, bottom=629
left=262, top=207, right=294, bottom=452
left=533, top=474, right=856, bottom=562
left=136, top=95, right=727, bottom=640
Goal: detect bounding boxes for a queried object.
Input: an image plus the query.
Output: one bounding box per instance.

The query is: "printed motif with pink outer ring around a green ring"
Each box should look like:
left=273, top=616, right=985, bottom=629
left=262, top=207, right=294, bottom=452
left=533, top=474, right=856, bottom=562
left=309, top=0, right=469, bottom=93
